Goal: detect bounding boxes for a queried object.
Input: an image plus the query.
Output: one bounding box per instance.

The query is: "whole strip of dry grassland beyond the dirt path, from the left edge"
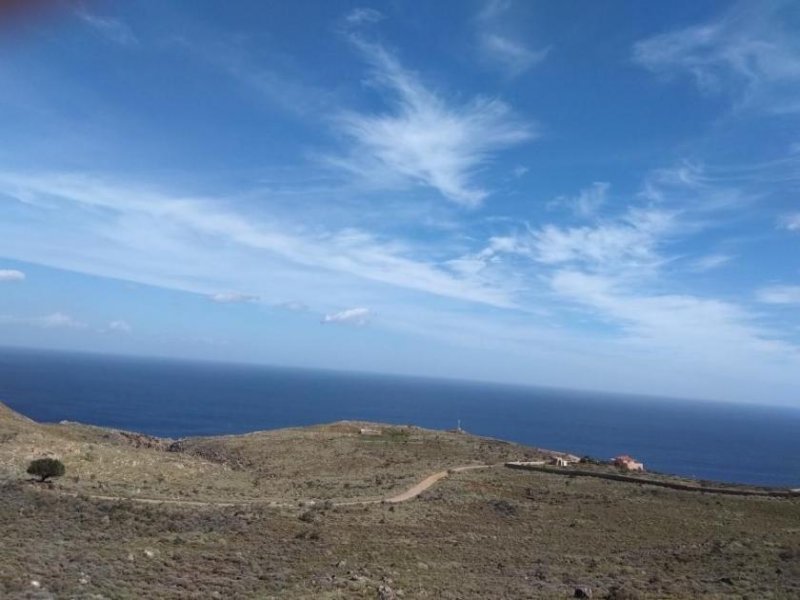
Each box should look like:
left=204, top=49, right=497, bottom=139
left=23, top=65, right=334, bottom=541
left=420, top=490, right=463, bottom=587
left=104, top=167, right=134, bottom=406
left=0, top=405, right=536, bottom=502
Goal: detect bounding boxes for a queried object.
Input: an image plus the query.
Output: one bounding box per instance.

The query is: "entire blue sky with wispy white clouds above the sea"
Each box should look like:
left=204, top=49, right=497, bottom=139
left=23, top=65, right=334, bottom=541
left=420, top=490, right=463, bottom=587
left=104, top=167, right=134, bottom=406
left=0, top=0, right=800, bottom=406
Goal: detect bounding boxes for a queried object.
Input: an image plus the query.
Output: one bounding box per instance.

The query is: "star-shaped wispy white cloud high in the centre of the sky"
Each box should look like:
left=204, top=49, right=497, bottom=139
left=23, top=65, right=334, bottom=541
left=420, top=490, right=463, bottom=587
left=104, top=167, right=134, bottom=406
left=331, top=35, right=533, bottom=206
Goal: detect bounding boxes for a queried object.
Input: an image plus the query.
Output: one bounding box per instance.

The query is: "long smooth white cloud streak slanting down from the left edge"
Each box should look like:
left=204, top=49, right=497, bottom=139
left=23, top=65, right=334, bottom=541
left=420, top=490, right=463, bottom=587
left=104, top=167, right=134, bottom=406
left=0, top=173, right=513, bottom=306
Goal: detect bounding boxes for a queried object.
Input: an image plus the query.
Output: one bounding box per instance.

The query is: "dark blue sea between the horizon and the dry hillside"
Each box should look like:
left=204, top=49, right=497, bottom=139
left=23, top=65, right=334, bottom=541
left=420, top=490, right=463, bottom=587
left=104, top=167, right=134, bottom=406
left=0, top=349, right=800, bottom=487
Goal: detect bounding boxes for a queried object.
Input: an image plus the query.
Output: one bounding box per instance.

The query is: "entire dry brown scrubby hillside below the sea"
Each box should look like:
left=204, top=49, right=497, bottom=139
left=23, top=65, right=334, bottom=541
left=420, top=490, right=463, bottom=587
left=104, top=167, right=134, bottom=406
left=0, top=405, right=800, bottom=598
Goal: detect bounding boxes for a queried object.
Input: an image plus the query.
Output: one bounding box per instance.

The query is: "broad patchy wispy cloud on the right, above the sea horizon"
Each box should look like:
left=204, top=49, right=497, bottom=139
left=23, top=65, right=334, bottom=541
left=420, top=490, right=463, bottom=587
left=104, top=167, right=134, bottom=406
left=438, top=155, right=800, bottom=396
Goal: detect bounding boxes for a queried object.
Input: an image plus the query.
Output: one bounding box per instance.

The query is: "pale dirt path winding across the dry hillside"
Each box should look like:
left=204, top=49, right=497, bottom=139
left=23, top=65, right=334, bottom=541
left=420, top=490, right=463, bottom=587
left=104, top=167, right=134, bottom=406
left=61, top=465, right=498, bottom=508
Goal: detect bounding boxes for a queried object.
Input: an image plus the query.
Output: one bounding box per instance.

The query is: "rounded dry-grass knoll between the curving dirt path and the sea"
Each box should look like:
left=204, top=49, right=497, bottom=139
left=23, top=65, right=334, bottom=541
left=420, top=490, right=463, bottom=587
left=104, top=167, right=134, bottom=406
left=176, top=422, right=538, bottom=500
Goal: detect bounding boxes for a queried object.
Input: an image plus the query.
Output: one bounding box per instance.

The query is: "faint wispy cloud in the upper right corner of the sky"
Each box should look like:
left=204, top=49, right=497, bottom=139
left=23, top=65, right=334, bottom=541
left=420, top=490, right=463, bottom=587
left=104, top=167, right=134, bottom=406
left=633, top=0, right=800, bottom=113
